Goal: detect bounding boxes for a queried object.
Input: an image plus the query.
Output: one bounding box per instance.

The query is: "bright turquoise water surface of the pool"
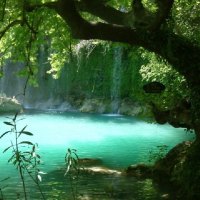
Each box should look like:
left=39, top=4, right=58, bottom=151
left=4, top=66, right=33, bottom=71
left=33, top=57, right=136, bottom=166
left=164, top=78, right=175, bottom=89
left=0, top=112, right=194, bottom=199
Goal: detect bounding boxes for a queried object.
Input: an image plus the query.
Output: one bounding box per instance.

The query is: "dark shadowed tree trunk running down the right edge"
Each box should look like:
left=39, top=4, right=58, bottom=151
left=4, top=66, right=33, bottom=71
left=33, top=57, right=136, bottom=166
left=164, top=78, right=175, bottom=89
left=172, top=85, right=200, bottom=200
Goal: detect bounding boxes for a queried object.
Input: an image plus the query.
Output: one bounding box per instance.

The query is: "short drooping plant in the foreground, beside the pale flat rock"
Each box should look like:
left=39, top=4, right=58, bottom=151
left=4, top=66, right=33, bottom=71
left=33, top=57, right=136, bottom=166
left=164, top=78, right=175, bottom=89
left=64, top=148, right=80, bottom=200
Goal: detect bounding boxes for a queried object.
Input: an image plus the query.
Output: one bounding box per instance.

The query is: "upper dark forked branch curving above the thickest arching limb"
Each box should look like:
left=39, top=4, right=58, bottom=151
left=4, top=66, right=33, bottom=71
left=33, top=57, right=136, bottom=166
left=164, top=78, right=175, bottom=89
left=75, top=0, right=174, bottom=31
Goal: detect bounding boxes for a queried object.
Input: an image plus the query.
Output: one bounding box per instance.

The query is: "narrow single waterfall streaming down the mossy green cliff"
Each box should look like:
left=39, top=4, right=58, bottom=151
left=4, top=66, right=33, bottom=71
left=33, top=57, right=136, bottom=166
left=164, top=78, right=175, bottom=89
left=111, top=46, right=123, bottom=113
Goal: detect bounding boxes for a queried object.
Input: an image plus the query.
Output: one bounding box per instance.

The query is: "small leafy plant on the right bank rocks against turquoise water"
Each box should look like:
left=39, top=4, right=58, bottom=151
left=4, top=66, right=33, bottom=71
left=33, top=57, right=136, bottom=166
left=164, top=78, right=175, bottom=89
left=148, top=144, right=169, bottom=163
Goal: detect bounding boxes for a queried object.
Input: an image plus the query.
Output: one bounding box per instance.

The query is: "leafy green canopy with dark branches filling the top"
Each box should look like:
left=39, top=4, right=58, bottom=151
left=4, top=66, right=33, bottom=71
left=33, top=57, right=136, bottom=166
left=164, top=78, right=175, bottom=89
left=0, top=0, right=200, bottom=79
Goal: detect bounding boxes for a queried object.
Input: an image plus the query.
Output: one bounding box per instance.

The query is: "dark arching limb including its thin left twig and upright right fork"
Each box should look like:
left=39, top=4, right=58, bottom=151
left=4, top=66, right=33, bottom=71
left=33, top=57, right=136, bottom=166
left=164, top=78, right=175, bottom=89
left=20, top=0, right=200, bottom=85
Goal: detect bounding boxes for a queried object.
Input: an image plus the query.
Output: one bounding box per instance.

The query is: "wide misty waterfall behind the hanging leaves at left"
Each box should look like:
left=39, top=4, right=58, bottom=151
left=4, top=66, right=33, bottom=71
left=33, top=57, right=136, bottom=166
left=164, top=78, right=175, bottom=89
left=0, top=47, right=71, bottom=111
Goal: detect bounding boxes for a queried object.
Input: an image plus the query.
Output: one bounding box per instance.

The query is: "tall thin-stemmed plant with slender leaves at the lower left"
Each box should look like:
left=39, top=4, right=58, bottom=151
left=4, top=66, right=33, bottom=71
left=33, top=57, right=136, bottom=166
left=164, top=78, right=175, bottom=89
left=0, top=113, right=45, bottom=200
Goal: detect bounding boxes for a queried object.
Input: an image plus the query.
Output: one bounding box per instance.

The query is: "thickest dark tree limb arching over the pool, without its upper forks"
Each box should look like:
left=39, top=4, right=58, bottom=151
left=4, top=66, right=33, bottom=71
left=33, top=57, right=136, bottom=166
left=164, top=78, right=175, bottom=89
left=56, top=0, right=200, bottom=77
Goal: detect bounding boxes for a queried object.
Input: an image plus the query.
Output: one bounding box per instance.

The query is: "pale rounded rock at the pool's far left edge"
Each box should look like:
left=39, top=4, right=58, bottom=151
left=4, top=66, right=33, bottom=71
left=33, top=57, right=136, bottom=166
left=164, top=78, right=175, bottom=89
left=0, top=97, right=22, bottom=113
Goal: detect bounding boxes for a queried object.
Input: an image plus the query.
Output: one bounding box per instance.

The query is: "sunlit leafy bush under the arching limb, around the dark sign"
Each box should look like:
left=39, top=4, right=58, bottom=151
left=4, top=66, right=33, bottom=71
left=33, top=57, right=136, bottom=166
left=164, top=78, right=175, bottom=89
left=137, top=51, right=190, bottom=110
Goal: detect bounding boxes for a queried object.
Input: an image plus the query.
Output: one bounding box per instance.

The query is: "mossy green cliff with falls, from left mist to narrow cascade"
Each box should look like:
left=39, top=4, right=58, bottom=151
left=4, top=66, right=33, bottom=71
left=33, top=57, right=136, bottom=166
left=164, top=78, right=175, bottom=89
left=0, top=41, right=123, bottom=113
